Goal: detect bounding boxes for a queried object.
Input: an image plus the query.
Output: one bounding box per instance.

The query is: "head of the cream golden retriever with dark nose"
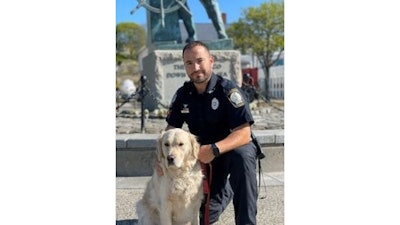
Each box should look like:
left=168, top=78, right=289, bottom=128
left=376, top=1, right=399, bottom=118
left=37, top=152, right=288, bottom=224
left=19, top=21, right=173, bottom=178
left=157, top=128, right=200, bottom=168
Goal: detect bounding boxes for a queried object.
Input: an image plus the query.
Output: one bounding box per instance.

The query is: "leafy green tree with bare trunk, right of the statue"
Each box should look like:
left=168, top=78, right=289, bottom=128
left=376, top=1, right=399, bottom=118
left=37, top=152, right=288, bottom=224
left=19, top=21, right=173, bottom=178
left=227, top=1, right=284, bottom=99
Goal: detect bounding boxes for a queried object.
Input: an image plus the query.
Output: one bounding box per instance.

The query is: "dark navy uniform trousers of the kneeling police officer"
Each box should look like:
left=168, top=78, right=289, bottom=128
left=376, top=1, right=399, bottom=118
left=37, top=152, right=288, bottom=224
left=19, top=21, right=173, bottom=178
left=201, top=142, right=258, bottom=225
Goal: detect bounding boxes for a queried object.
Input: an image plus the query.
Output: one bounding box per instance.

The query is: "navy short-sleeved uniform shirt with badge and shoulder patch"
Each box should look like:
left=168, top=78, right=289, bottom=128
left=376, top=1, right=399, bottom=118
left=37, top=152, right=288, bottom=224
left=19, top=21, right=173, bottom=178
left=166, top=73, right=254, bottom=145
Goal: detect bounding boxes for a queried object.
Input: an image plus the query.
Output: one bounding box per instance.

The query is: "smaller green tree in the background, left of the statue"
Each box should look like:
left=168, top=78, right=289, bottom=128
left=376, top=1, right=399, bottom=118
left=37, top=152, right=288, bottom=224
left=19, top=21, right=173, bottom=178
left=116, top=23, right=146, bottom=60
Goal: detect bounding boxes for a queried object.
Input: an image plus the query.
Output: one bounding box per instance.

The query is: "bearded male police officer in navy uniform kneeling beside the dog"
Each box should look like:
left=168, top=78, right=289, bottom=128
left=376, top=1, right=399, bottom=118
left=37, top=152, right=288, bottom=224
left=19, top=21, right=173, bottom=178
left=166, top=41, right=257, bottom=225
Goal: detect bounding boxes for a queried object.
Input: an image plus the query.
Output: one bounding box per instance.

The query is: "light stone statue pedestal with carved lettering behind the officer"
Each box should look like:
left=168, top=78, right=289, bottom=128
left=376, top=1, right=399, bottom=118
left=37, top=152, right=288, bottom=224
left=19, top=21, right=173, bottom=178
left=141, top=47, right=242, bottom=111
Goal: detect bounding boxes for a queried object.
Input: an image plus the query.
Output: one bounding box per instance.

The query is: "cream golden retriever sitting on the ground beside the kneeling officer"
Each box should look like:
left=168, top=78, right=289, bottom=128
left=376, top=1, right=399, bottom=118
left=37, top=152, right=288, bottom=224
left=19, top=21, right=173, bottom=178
left=136, top=128, right=203, bottom=225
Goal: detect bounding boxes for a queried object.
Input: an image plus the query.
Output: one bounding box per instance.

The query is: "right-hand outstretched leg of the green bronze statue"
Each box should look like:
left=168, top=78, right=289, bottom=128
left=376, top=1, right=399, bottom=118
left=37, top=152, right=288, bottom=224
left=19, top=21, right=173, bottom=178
left=200, top=0, right=228, bottom=39
